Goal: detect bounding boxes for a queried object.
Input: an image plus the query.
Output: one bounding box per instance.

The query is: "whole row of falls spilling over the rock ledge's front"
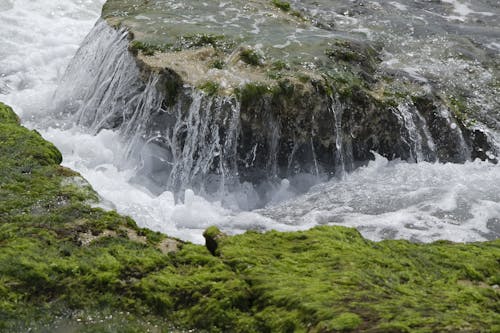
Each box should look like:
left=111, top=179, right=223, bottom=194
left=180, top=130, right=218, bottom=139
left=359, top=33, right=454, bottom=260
left=54, top=20, right=492, bottom=207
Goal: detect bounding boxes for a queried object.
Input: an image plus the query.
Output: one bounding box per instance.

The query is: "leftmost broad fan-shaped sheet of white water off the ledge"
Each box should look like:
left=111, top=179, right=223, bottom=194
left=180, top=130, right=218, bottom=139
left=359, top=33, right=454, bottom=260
left=54, top=20, right=145, bottom=134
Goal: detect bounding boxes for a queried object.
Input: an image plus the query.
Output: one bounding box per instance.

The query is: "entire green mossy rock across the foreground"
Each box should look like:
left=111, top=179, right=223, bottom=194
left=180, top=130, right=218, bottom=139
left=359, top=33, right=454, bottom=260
left=0, top=100, right=500, bottom=332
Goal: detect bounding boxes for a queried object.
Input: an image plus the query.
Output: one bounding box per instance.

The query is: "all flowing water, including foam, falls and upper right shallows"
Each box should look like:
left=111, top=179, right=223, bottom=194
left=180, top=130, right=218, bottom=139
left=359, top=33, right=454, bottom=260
left=0, top=0, right=500, bottom=243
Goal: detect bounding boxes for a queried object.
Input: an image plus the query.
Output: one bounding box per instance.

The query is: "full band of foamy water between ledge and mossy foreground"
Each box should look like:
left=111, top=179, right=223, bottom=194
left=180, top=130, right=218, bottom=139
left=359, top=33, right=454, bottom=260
left=43, top=129, right=500, bottom=243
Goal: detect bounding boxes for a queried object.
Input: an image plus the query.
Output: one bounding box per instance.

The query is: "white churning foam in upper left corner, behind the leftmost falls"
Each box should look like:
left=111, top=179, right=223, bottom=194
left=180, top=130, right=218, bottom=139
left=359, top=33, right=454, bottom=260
left=0, top=0, right=104, bottom=116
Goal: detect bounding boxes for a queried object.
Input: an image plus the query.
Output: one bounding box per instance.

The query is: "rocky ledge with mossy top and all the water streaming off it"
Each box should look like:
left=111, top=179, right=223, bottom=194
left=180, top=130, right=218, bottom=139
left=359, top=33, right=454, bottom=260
left=52, top=0, right=496, bottom=197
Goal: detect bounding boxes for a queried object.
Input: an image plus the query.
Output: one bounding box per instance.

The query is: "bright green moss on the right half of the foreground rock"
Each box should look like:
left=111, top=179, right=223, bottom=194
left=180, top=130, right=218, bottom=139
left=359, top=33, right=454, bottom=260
left=215, top=227, right=500, bottom=332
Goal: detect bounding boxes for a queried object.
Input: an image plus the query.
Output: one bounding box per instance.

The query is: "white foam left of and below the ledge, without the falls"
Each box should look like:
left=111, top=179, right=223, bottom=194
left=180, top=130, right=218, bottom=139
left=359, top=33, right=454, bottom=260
left=0, top=0, right=500, bottom=242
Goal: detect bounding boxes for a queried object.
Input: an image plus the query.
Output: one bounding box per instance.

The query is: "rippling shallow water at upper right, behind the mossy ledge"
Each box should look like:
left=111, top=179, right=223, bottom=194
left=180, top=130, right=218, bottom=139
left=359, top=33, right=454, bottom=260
left=291, top=0, right=500, bottom=129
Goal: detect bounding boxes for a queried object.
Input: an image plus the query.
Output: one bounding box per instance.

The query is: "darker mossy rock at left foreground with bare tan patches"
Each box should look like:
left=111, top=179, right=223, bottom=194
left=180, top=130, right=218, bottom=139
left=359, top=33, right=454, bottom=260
left=0, top=103, right=176, bottom=332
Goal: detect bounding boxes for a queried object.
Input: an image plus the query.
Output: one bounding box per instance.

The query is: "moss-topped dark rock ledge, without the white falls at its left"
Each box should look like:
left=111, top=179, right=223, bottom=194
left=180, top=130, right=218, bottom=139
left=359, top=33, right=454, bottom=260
left=92, top=0, right=494, bottom=191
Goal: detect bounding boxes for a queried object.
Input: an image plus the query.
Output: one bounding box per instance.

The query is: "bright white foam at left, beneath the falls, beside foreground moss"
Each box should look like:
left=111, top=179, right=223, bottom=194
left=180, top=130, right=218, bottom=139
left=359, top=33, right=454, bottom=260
left=36, top=124, right=316, bottom=243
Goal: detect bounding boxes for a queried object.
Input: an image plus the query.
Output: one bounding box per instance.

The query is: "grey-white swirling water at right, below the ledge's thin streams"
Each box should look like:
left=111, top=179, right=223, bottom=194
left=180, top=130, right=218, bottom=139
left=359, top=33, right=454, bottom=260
left=260, top=155, right=500, bottom=242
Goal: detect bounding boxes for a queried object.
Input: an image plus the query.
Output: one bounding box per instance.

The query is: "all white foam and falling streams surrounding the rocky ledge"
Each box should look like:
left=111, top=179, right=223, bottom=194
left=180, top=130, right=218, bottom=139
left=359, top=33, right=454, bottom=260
left=0, top=1, right=500, bottom=242
